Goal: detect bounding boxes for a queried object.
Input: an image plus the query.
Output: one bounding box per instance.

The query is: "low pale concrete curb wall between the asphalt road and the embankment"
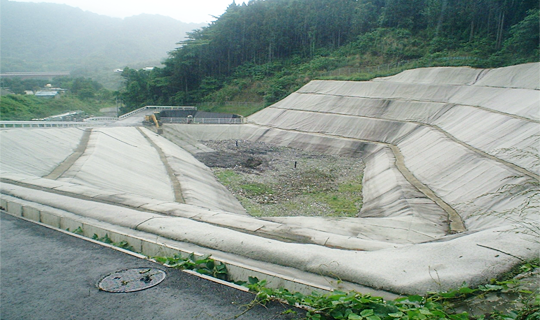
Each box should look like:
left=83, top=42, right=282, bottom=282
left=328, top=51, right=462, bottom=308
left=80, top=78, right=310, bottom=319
left=0, top=194, right=398, bottom=300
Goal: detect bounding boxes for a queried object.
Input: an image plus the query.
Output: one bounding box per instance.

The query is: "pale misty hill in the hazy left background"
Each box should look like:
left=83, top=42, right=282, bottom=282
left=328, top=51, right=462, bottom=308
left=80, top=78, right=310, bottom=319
left=0, top=0, right=204, bottom=73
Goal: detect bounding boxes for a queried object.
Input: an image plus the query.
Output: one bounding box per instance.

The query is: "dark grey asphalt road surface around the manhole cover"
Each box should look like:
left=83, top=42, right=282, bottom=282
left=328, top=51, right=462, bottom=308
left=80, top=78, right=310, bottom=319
left=0, top=212, right=303, bottom=320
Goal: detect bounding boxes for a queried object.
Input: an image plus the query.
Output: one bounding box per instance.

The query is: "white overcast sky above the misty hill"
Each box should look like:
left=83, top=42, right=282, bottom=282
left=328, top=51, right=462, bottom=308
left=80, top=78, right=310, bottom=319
left=7, top=0, right=240, bottom=23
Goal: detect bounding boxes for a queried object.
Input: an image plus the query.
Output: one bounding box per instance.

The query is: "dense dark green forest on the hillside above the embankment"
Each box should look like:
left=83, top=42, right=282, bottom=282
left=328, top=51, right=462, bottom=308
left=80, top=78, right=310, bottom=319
left=120, top=0, right=539, bottom=111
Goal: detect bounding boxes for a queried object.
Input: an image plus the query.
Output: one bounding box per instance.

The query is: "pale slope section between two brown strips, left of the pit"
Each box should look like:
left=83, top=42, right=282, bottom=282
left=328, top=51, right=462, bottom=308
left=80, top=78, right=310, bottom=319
left=59, top=127, right=175, bottom=201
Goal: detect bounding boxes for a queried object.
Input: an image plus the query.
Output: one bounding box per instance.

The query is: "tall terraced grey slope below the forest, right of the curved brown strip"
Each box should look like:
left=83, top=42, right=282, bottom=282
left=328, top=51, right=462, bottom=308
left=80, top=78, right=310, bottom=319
left=249, top=64, right=540, bottom=230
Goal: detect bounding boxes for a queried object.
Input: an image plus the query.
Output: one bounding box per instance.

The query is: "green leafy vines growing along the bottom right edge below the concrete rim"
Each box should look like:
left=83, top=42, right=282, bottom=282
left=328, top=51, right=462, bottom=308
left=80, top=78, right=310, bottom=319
left=242, top=262, right=540, bottom=320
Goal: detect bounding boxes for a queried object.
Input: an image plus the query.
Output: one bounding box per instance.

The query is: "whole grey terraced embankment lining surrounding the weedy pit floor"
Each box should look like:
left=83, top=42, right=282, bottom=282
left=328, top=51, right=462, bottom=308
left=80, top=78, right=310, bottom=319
left=0, top=64, right=540, bottom=293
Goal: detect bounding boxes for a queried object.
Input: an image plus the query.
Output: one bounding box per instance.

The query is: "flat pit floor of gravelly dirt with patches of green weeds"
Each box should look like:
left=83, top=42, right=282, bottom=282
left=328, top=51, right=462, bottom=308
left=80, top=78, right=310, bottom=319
left=195, top=140, right=364, bottom=217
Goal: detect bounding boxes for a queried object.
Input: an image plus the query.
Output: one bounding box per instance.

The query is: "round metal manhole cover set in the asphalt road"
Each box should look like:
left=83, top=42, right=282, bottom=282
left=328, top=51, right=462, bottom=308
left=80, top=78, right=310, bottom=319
left=98, top=268, right=166, bottom=292
